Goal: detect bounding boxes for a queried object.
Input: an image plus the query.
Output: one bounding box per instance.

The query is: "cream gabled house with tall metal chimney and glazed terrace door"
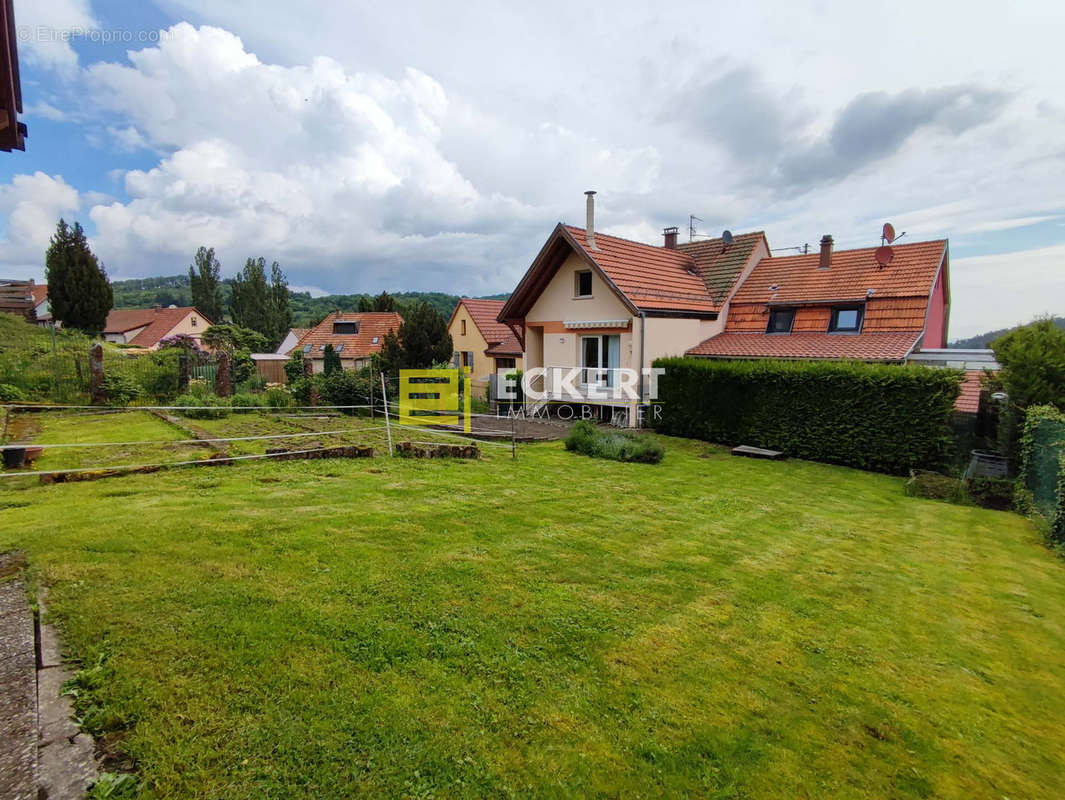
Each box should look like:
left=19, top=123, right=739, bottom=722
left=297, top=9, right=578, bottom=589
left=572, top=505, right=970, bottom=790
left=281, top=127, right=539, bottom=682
left=497, top=194, right=769, bottom=424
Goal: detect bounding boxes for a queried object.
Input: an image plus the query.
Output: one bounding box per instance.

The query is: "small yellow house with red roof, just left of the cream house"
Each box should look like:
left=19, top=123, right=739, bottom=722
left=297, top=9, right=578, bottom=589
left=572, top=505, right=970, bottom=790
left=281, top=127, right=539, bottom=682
left=447, top=297, right=522, bottom=394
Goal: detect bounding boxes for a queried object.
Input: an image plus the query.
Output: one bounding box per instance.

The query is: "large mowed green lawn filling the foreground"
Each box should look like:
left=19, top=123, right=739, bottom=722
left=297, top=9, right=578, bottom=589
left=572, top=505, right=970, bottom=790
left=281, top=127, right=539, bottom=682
left=0, top=421, right=1065, bottom=798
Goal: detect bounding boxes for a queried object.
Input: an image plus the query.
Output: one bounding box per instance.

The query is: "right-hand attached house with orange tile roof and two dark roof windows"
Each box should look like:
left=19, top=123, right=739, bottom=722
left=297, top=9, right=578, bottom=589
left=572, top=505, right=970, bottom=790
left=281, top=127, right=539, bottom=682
left=688, top=236, right=950, bottom=362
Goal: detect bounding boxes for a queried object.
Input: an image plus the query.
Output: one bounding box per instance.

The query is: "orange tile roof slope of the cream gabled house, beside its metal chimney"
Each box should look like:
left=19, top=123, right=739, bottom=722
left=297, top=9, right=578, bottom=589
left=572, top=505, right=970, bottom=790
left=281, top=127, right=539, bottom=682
left=564, top=225, right=718, bottom=311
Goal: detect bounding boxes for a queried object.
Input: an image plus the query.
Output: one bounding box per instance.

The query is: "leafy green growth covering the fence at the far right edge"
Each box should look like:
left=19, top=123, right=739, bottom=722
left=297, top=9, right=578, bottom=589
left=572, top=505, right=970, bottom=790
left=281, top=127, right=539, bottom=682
left=1018, top=406, right=1065, bottom=542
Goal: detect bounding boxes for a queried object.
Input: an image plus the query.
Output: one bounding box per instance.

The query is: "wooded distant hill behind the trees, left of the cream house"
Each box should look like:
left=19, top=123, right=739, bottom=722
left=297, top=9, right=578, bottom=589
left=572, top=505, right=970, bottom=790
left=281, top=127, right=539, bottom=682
left=111, top=275, right=510, bottom=327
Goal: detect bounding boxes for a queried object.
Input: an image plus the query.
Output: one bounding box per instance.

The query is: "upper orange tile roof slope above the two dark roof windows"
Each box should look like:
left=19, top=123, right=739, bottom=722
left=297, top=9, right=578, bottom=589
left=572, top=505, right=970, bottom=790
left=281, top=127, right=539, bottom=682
left=733, top=240, right=947, bottom=304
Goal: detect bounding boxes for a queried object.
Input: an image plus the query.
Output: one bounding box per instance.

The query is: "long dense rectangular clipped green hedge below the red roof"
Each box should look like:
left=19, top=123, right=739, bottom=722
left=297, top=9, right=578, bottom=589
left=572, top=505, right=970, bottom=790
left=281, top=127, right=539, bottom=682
left=654, top=358, right=961, bottom=475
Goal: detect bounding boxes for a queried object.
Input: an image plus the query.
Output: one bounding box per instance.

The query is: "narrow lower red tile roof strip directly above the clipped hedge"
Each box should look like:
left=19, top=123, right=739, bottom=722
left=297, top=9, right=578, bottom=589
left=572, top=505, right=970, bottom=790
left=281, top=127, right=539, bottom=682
left=688, top=330, right=921, bottom=361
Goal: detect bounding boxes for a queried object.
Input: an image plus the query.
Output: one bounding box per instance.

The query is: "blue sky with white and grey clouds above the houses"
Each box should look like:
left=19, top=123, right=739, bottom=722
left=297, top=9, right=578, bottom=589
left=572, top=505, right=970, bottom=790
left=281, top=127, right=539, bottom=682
left=0, top=0, right=1065, bottom=338
